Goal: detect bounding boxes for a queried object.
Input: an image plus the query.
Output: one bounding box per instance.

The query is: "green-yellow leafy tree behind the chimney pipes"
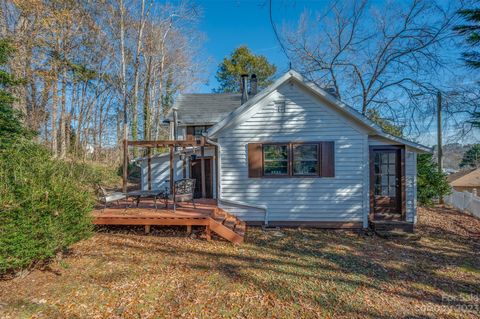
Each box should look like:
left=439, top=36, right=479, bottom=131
left=214, top=46, right=277, bottom=93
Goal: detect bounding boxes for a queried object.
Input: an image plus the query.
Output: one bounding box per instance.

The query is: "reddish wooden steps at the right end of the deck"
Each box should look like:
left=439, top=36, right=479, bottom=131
left=210, top=207, right=246, bottom=244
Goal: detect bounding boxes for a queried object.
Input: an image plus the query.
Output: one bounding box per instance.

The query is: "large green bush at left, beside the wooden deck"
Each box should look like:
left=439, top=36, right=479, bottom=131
left=0, top=140, right=99, bottom=274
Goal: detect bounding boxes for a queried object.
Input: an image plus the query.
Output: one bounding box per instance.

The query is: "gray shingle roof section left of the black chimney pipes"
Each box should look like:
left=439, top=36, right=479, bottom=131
left=167, top=93, right=242, bottom=124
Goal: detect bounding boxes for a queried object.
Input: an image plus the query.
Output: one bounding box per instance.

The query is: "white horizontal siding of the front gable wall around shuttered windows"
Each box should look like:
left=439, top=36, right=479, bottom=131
left=218, top=84, right=368, bottom=222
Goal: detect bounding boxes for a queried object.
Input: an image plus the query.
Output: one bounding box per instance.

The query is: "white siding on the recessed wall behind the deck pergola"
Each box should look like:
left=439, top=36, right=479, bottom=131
left=140, top=147, right=216, bottom=198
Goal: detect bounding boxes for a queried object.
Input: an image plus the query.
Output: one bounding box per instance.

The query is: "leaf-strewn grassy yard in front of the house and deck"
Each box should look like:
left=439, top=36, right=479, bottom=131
left=0, top=208, right=480, bottom=318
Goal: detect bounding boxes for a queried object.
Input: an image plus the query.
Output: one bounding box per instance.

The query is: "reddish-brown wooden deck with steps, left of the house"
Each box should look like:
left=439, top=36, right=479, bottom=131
left=92, top=199, right=246, bottom=244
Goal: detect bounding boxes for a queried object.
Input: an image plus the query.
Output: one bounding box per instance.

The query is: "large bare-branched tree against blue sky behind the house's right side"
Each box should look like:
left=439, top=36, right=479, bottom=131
left=286, top=0, right=462, bottom=116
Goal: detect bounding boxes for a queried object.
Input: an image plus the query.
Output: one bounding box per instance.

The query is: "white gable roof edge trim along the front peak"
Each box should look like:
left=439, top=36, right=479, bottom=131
left=206, top=70, right=432, bottom=153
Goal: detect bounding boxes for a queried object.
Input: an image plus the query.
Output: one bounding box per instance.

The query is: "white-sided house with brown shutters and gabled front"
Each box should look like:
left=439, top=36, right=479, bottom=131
left=136, top=70, right=431, bottom=228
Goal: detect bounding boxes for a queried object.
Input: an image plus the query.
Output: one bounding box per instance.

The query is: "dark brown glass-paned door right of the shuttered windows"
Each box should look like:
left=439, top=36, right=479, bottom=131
left=370, top=148, right=402, bottom=220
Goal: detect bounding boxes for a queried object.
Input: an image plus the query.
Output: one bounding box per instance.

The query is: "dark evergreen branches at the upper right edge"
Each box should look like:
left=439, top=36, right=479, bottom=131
left=453, top=8, right=480, bottom=69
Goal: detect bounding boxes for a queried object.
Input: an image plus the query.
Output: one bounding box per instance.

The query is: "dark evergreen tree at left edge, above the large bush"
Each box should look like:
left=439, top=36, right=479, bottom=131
left=0, top=39, right=33, bottom=148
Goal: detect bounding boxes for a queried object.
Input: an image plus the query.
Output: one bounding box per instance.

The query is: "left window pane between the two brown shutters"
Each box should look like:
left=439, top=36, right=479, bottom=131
left=263, top=144, right=289, bottom=176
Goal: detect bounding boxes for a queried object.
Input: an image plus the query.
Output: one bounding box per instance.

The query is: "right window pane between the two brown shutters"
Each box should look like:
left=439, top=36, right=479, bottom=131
left=293, top=144, right=319, bottom=176
